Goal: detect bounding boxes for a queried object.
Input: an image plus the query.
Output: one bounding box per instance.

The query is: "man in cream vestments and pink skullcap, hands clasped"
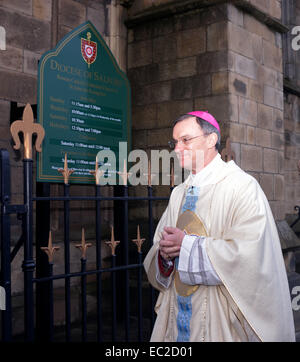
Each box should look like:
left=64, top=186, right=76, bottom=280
left=144, top=111, right=295, bottom=342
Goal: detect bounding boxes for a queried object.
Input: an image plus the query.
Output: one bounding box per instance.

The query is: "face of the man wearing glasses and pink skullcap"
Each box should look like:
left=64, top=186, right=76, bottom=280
left=173, top=117, right=212, bottom=173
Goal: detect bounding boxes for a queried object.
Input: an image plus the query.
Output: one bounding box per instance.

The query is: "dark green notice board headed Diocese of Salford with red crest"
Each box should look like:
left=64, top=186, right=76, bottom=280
left=37, top=22, right=131, bottom=183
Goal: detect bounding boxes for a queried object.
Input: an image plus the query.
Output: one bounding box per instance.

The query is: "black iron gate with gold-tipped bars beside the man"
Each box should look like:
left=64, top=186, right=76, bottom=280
left=0, top=141, right=168, bottom=342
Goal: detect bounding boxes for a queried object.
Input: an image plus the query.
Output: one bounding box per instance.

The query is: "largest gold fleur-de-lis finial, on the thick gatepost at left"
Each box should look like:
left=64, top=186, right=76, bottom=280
left=10, top=103, right=45, bottom=159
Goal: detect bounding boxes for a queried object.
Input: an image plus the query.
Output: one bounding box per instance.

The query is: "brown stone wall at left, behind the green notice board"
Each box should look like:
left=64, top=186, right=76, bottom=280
left=0, top=0, right=109, bottom=242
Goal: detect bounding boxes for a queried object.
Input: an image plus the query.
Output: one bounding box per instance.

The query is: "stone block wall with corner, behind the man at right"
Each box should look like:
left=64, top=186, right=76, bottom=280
left=128, top=1, right=285, bottom=220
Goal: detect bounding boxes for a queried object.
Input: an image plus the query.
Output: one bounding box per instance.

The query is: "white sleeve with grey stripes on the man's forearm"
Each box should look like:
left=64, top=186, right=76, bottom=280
left=178, top=235, right=222, bottom=285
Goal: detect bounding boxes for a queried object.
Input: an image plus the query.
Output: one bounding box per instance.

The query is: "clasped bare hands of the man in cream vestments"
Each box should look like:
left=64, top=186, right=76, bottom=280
left=159, top=226, right=185, bottom=260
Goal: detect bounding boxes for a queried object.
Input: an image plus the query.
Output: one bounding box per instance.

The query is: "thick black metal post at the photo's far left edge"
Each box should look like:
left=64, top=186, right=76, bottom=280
left=0, top=149, right=12, bottom=342
